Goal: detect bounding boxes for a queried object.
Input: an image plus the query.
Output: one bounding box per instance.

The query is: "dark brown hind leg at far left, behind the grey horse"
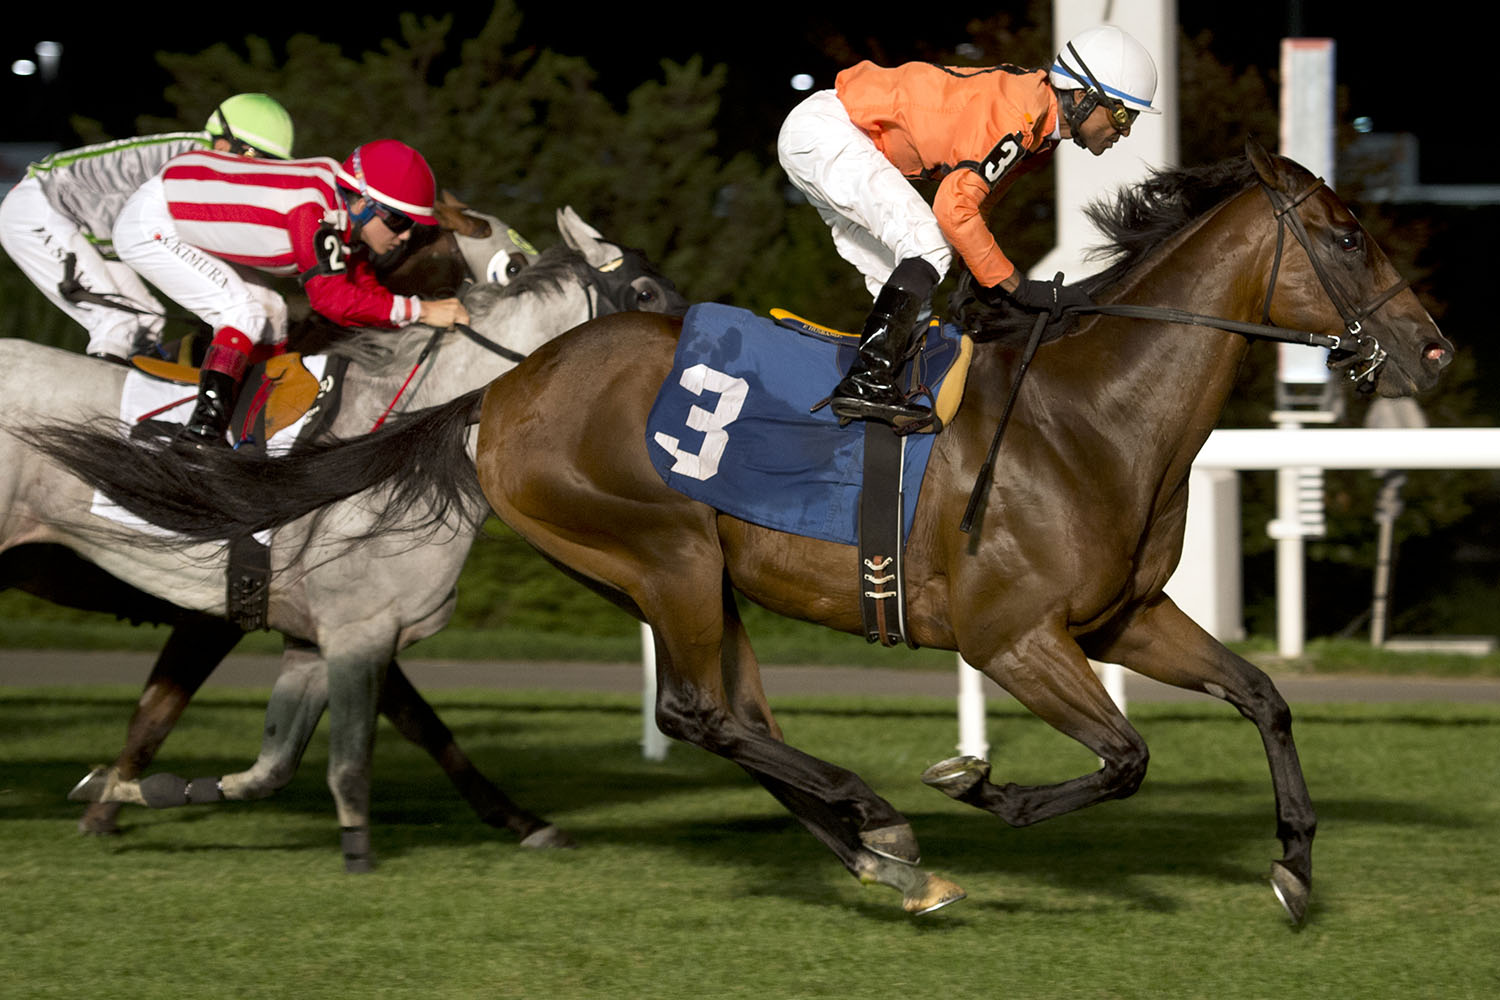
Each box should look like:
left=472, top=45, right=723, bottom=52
left=72, top=618, right=245, bottom=834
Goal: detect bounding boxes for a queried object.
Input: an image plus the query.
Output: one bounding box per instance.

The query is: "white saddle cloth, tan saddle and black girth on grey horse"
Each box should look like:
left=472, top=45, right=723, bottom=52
left=90, top=354, right=338, bottom=631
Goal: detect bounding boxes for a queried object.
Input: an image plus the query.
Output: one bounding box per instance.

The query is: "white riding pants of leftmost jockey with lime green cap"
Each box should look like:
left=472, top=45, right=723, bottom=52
left=0, top=177, right=165, bottom=358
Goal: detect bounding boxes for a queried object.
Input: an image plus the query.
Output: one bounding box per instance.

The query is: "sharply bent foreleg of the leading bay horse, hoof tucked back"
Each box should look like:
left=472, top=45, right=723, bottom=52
left=923, top=625, right=1149, bottom=826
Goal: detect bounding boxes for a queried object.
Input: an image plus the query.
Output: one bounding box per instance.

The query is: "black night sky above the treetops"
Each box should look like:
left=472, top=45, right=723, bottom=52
left=0, top=0, right=1476, bottom=183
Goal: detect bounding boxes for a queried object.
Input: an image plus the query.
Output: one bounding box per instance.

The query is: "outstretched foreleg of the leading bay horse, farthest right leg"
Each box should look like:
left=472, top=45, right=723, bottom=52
left=1095, top=595, right=1317, bottom=924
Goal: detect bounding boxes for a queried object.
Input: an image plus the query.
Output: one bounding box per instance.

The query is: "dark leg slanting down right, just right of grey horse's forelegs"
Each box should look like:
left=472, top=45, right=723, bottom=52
left=380, top=660, right=573, bottom=847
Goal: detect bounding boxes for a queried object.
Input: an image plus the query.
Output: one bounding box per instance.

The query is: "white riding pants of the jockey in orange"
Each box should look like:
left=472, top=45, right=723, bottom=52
left=776, top=90, right=953, bottom=297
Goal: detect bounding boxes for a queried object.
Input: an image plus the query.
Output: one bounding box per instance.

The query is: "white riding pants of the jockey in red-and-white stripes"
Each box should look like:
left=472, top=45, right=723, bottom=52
left=114, top=177, right=287, bottom=350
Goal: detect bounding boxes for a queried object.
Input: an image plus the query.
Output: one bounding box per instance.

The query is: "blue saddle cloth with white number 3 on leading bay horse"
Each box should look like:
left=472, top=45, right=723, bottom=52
left=647, top=303, right=966, bottom=544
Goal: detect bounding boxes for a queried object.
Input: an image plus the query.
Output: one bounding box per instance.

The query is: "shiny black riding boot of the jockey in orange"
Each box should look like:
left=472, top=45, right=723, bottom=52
left=828, top=258, right=938, bottom=426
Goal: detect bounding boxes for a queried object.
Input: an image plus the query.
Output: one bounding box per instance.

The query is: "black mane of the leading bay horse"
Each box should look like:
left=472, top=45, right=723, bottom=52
left=948, top=156, right=1256, bottom=340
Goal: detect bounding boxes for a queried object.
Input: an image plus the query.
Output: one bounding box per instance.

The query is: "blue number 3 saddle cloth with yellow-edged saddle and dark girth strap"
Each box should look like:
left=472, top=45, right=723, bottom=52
left=647, top=303, right=972, bottom=645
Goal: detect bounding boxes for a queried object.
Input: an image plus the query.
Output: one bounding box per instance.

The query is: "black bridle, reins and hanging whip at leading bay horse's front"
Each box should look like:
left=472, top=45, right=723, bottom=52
left=959, top=177, right=1407, bottom=534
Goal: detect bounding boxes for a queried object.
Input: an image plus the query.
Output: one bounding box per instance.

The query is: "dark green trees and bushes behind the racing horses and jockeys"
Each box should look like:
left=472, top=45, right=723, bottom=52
left=0, top=0, right=1500, bottom=634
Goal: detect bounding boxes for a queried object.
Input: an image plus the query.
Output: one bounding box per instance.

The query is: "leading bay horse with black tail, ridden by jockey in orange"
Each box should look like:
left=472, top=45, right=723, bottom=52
left=26, top=144, right=1452, bottom=922
